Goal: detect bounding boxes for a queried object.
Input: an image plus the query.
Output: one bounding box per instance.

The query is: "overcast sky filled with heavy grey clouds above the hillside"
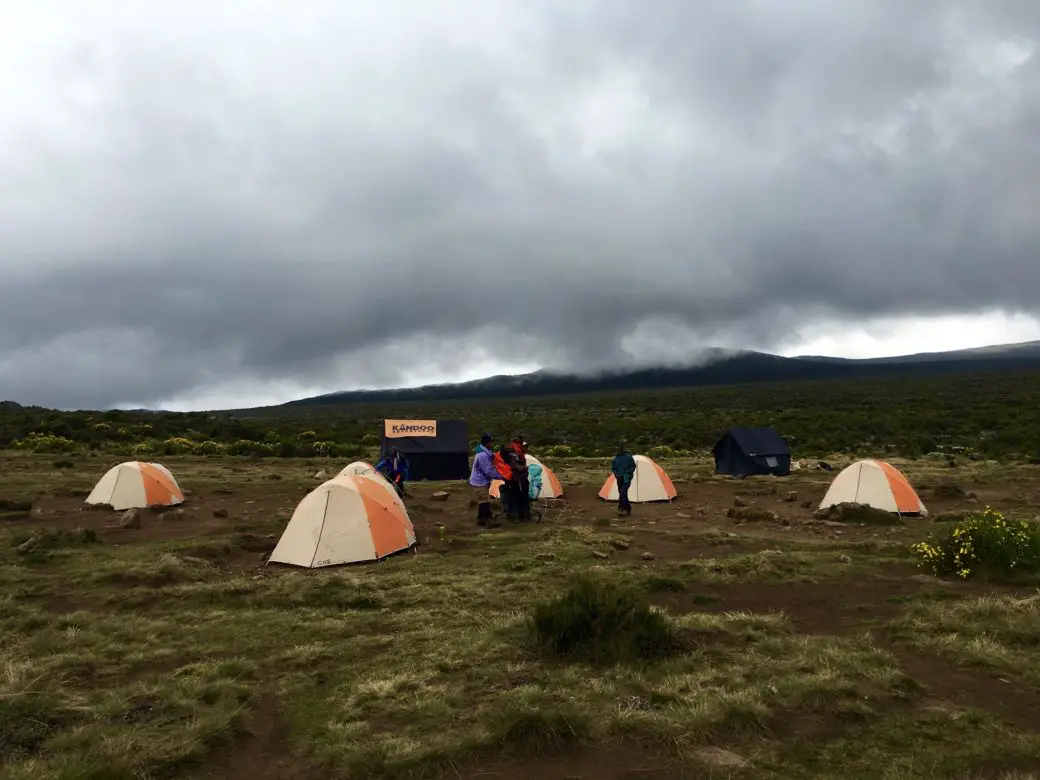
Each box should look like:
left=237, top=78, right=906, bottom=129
left=0, top=0, right=1040, bottom=416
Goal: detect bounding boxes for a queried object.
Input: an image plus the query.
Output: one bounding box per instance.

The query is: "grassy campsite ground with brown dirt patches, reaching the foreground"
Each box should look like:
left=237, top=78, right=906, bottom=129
left=0, top=453, right=1040, bottom=780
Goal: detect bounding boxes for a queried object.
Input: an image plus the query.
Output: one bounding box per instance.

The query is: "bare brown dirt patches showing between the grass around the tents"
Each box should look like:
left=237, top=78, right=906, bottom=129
left=6, top=461, right=1040, bottom=780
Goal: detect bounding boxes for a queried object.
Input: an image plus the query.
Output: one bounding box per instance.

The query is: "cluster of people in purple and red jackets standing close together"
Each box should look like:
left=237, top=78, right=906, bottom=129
left=469, top=434, right=541, bottom=526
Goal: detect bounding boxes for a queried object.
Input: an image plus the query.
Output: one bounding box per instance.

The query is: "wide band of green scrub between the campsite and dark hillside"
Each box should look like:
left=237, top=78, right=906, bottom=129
left=6, top=372, right=1040, bottom=459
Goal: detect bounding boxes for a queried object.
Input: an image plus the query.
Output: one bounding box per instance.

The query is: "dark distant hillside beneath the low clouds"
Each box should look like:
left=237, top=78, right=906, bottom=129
left=278, top=341, right=1040, bottom=409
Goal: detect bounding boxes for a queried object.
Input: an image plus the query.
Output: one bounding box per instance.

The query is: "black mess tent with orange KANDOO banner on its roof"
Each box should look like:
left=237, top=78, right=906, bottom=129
left=383, top=420, right=469, bottom=482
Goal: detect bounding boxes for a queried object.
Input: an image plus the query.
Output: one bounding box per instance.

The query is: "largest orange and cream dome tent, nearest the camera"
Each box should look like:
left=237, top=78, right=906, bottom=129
left=268, top=476, right=415, bottom=569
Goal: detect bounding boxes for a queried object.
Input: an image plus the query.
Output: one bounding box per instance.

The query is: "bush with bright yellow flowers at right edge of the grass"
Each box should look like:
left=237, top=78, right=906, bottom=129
left=913, top=506, right=1040, bottom=579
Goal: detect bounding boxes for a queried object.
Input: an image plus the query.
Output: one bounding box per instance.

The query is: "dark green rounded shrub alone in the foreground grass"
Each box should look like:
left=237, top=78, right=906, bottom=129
left=528, top=577, right=679, bottom=662
